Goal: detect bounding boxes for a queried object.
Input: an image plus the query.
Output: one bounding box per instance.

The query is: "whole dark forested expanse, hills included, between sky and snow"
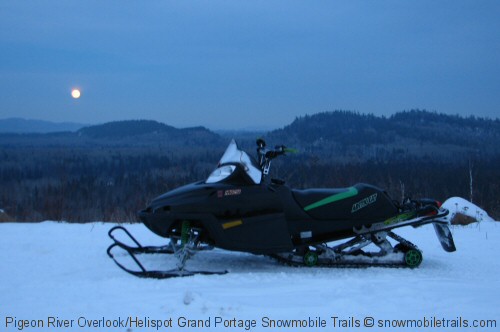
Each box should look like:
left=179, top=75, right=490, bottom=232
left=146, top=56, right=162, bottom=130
left=0, top=110, right=500, bottom=222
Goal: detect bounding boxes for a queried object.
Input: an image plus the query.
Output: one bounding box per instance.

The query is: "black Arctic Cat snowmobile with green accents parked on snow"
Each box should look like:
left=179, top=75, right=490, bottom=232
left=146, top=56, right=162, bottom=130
left=107, top=139, right=456, bottom=278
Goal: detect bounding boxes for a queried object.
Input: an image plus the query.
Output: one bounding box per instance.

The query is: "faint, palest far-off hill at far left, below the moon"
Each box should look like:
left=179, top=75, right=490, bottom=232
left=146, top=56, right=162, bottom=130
left=0, top=118, right=85, bottom=133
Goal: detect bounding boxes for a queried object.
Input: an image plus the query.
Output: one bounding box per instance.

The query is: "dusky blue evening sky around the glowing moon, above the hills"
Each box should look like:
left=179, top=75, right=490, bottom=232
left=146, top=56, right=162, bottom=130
left=0, top=0, right=500, bottom=129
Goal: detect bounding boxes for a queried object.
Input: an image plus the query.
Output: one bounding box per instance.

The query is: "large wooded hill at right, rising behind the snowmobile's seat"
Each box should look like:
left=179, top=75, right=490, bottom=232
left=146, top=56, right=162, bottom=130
left=266, top=110, right=500, bottom=161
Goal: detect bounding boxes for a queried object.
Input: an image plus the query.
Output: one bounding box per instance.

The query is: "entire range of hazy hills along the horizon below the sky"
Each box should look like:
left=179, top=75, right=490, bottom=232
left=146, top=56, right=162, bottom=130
left=0, top=110, right=500, bottom=163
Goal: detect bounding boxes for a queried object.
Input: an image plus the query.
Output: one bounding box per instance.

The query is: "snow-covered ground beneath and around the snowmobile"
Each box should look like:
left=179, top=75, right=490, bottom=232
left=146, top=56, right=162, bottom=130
left=0, top=202, right=500, bottom=331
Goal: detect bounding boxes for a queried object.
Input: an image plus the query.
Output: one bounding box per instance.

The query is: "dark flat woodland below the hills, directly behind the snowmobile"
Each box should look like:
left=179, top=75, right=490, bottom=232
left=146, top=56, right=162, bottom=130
left=0, top=143, right=500, bottom=222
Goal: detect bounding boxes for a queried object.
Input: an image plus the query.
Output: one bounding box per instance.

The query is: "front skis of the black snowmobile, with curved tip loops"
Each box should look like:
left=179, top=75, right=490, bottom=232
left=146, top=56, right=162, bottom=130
left=106, top=226, right=227, bottom=279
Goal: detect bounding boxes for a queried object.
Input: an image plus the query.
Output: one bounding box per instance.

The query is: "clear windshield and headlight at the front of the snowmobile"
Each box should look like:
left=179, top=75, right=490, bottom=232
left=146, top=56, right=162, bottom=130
left=206, top=139, right=262, bottom=184
